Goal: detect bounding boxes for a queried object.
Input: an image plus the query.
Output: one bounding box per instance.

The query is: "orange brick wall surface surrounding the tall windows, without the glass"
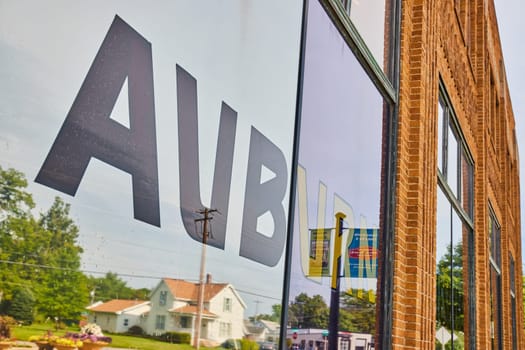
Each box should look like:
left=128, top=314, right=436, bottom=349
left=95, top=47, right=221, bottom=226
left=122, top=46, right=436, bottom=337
left=392, top=0, right=525, bottom=350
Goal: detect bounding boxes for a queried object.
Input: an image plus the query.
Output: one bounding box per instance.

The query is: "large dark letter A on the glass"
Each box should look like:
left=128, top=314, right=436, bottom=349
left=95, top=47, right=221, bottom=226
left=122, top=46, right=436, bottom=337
left=35, top=16, right=160, bottom=227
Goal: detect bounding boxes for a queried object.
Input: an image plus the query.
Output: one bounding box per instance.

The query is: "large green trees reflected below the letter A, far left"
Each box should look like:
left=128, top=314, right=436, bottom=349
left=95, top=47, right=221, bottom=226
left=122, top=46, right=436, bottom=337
left=0, top=167, right=88, bottom=319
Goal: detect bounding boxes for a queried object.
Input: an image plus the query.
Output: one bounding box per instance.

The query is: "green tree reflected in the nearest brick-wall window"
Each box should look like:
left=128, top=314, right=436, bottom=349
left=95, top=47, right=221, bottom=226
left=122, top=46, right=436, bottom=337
left=436, top=243, right=465, bottom=331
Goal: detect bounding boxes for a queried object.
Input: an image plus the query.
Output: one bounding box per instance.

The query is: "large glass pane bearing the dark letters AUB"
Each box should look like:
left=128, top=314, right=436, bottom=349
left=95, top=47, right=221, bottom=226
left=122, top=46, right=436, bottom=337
left=0, top=0, right=302, bottom=344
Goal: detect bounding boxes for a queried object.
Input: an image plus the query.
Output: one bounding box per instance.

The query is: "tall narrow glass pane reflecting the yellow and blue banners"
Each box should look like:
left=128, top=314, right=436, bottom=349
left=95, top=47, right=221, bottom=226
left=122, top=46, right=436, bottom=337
left=288, top=1, right=383, bottom=348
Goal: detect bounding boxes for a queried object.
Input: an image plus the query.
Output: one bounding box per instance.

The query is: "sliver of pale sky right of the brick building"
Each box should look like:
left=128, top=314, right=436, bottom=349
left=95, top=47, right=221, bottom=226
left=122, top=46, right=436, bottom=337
left=495, top=0, right=525, bottom=262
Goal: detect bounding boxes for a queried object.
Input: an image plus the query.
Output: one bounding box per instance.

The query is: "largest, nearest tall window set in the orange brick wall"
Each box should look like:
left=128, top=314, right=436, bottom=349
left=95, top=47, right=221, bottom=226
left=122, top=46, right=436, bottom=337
left=436, top=87, right=475, bottom=349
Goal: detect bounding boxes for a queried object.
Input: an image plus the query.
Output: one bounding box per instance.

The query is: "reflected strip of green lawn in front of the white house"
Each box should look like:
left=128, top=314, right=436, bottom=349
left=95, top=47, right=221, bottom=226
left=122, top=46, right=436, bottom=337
left=11, top=323, right=218, bottom=350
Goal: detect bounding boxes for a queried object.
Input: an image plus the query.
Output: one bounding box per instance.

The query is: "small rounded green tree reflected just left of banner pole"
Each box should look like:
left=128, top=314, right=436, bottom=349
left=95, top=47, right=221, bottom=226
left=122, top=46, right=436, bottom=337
left=288, top=293, right=330, bottom=328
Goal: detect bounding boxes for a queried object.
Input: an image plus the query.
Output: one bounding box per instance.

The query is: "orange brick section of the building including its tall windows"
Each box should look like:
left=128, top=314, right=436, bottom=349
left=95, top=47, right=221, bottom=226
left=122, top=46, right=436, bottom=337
left=392, top=1, right=524, bottom=349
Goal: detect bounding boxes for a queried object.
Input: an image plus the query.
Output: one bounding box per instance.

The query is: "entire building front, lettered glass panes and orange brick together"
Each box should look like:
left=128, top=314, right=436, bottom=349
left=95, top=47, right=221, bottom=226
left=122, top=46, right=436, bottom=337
left=0, top=0, right=525, bottom=350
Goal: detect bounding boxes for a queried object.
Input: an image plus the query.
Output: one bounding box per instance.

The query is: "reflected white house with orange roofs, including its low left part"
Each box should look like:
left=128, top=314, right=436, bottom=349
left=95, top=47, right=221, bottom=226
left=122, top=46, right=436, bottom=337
left=87, top=275, right=247, bottom=345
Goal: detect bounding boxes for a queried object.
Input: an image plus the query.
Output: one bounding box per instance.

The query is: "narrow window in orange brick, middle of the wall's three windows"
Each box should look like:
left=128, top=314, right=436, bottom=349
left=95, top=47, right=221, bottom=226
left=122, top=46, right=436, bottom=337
left=489, top=210, right=503, bottom=350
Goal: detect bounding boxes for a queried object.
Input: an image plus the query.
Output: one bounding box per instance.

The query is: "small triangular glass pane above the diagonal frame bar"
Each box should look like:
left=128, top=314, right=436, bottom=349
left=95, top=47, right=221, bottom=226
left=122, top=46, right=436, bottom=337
left=347, top=0, right=389, bottom=73
